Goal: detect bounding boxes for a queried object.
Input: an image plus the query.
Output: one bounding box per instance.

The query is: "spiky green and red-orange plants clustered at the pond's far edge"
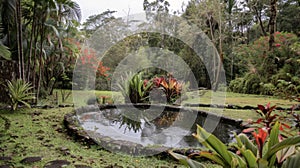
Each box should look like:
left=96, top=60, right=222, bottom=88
left=117, top=72, right=184, bottom=104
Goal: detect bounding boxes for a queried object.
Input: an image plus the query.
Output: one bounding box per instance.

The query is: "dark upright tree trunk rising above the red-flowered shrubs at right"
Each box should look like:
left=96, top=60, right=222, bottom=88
left=269, top=0, right=277, bottom=51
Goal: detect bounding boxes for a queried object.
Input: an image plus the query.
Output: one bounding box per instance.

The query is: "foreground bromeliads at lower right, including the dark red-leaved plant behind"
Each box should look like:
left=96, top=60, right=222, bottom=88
left=170, top=103, right=300, bottom=168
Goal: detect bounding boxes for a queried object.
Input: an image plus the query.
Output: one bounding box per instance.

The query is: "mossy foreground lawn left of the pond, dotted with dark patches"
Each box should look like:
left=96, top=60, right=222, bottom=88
left=0, top=108, right=217, bottom=168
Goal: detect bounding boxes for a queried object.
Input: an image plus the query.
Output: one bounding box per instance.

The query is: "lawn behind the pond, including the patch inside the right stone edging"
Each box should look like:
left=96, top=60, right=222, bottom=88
left=45, top=90, right=299, bottom=120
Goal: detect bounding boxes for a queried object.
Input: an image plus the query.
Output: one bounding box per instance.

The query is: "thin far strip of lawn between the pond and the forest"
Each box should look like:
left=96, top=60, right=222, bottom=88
left=49, top=90, right=299, bottom=108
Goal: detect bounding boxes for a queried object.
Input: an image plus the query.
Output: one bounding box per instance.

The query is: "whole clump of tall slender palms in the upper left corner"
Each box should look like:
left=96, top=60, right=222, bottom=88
left=0, top=0, right=81, bottom=102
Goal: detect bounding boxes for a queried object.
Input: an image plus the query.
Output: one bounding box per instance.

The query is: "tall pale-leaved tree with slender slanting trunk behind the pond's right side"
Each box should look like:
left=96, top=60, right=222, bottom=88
left=183, top=0, right=226, bottom=90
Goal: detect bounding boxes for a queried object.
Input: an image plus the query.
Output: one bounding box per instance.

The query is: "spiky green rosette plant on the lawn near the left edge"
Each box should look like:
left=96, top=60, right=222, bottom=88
left=7, top=79, right=35, bottom=111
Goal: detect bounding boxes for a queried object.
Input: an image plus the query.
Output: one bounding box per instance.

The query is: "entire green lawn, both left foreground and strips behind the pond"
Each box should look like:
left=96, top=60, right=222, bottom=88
left=0, top=90, right=299, bottom=168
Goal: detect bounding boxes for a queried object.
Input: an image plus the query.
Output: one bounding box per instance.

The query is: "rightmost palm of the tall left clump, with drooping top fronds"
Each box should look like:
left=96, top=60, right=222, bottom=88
left=33, top=0, right=81, bottom=100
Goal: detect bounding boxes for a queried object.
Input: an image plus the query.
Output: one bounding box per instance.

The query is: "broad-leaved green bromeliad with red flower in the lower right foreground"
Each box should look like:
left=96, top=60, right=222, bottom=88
left=169, top=122, right=300, bottom=168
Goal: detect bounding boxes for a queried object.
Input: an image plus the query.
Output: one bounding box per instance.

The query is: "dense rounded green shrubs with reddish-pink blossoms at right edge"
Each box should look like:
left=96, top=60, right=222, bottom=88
left=229, top=32, right=300, bottom=98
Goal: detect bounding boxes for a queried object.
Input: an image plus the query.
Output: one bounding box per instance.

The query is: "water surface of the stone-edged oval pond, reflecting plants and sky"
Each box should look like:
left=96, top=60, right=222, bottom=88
left=77, top=105, right=242, bottom=148
